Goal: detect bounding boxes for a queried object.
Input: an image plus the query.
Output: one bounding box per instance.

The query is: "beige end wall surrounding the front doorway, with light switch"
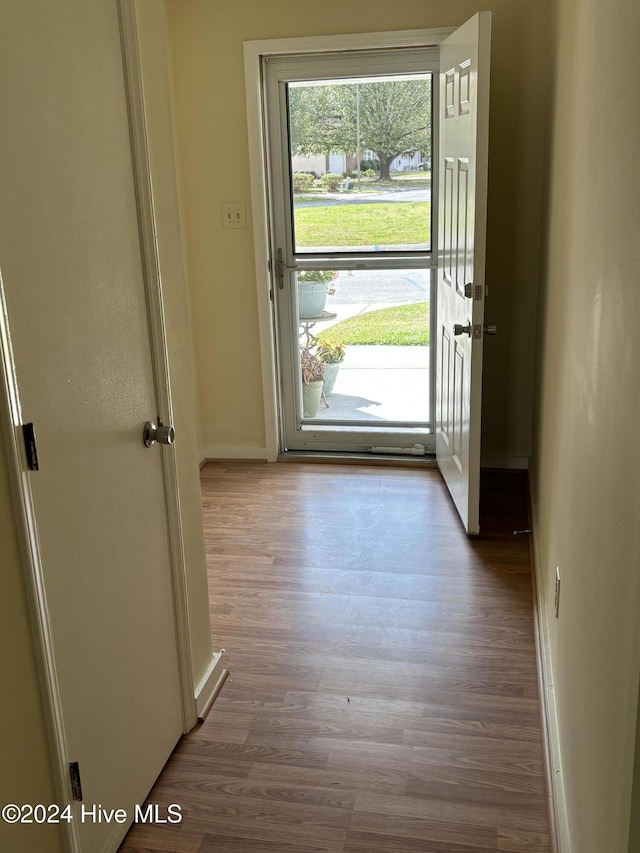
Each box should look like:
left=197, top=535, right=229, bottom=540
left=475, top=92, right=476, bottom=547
left=167, top=0, right=549, bottom=462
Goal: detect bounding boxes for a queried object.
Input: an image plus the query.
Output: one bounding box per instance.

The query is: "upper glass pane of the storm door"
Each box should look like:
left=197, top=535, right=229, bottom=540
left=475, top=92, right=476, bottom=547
left=287, top=73, right=432, bottom=254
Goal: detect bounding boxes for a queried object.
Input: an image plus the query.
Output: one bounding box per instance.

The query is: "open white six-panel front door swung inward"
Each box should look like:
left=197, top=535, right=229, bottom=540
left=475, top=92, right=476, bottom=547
left=436, top=12, right=491, bottom=533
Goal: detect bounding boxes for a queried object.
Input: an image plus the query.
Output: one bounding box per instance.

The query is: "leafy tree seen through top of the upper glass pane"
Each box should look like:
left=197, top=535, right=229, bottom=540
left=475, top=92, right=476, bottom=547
left=289, top=77, right=431, bottom=180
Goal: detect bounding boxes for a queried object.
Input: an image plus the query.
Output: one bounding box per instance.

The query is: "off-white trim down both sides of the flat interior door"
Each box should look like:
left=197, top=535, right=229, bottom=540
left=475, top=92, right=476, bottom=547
left=0, top=5, right=199, bottom=853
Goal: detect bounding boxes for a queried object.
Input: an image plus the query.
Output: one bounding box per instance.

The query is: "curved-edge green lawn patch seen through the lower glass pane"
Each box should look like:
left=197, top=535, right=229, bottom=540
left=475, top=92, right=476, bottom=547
left=318, top=302, right=429, bottom=346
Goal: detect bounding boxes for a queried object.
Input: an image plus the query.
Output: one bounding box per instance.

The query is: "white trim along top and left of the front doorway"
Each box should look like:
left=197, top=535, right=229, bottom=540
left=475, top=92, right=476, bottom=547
left=244, top=27, right=455, bottom=462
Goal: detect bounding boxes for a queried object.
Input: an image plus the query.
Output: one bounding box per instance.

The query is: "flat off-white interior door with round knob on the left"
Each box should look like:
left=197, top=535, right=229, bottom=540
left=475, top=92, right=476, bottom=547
left=0, top=0, right=183, bottom=853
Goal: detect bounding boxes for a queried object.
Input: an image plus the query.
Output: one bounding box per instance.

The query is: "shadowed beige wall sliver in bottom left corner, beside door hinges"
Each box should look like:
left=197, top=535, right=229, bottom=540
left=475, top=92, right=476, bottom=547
left=0, top=434, right=62, bottom=853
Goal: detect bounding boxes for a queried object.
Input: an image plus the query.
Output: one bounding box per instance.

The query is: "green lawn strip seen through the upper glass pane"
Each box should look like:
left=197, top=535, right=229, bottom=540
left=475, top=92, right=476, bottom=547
left=295, top=201, right=431, bottom=247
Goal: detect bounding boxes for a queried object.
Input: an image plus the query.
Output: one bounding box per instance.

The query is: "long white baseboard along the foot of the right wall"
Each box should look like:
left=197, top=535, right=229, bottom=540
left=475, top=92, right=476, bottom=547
left=532, top=518, right=571, bottom=853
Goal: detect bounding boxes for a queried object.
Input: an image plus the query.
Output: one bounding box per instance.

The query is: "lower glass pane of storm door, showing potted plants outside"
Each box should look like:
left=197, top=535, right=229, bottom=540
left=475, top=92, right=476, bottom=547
left=297, top=269, right=430, bottom=426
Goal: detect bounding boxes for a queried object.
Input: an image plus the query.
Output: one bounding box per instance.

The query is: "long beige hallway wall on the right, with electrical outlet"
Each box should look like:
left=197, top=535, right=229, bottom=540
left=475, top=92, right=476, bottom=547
left=533, top=0, right=640, bottom=853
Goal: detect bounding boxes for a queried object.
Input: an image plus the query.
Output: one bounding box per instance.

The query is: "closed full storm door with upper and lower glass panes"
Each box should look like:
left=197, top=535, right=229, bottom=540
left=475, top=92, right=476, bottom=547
left=265, top=48, right=438, bottom=453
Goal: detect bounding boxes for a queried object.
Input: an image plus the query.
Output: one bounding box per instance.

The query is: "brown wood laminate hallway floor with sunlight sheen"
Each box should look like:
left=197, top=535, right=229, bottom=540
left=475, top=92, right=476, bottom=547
left=121, top=463, right=550, bottom=853
